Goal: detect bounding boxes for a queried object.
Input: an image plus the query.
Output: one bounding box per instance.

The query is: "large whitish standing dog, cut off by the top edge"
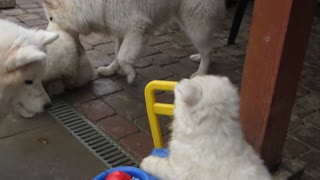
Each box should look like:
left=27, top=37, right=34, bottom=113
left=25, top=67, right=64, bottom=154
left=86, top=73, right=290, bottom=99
left=42, top=0, right=225, bottom=83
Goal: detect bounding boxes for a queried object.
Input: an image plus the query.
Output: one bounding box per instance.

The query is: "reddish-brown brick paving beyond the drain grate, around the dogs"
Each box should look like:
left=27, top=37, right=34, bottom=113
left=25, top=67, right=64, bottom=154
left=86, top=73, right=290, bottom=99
left=0, top=0, right=320, bottom=180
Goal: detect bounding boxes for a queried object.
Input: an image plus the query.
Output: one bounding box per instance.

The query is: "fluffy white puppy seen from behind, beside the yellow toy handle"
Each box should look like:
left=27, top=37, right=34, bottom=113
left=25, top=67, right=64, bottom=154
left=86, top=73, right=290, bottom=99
left=140, top=76, right=271, bottom=180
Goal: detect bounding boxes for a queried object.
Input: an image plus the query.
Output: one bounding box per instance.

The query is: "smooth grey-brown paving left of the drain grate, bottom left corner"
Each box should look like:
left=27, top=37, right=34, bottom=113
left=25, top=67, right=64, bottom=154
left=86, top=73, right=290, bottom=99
left=0, top=113, right=105, bottom=180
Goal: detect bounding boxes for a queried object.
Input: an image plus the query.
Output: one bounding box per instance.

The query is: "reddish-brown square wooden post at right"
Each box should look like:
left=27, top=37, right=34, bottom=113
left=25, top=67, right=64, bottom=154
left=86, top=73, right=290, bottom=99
left=240, top=0, right=316, bottom=168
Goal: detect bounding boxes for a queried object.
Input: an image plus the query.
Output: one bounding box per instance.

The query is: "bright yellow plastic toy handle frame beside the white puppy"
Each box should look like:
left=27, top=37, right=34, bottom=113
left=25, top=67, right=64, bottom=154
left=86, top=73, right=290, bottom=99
left=144, top=80, right=178, bottom=148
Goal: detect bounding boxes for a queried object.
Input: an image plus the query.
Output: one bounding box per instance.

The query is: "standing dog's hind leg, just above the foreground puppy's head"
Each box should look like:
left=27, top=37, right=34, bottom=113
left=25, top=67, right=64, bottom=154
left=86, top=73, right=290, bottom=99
left=178, top=0, right=225, bottom=76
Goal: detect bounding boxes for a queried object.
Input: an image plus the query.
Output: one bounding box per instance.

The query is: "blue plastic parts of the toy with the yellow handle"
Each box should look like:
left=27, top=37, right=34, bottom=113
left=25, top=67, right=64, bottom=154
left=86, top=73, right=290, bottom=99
left=93, top=148, right=169, bottom=180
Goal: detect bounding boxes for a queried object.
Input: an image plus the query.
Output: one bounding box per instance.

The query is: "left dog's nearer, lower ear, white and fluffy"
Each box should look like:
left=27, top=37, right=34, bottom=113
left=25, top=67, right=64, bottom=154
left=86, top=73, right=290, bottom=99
left=5, top=46, right=47, bottom=72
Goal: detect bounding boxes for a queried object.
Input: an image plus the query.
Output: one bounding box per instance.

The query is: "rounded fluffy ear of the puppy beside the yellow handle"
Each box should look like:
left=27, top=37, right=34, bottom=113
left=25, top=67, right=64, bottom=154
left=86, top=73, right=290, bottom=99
left=175, top=79, right=202, bottom=106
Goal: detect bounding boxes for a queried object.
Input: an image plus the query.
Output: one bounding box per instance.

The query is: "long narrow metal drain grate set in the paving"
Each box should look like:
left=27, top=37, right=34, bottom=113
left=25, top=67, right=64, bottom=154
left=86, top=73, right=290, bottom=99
left=48, top=100, right=138, bottom=168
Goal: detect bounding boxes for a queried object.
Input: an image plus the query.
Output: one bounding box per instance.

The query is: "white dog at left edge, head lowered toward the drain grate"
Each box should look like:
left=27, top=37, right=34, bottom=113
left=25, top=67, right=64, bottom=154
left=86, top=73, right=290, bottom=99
left=0, top=19, right=58, bottom=119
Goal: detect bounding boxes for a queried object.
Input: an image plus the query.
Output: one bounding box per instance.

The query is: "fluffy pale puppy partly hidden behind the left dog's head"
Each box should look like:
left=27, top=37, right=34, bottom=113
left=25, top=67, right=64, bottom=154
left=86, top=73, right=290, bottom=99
left=43, top=22, right=93, bottom=96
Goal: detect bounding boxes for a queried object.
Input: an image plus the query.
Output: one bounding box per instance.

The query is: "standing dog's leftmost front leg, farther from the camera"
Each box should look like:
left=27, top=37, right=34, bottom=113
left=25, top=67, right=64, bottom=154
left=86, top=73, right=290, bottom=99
left=97, top=37, right=123, bottom=76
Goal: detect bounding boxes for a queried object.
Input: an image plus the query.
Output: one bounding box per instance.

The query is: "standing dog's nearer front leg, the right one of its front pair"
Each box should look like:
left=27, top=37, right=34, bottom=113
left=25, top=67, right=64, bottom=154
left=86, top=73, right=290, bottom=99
left=117, top=32, right=145, bottom=84
